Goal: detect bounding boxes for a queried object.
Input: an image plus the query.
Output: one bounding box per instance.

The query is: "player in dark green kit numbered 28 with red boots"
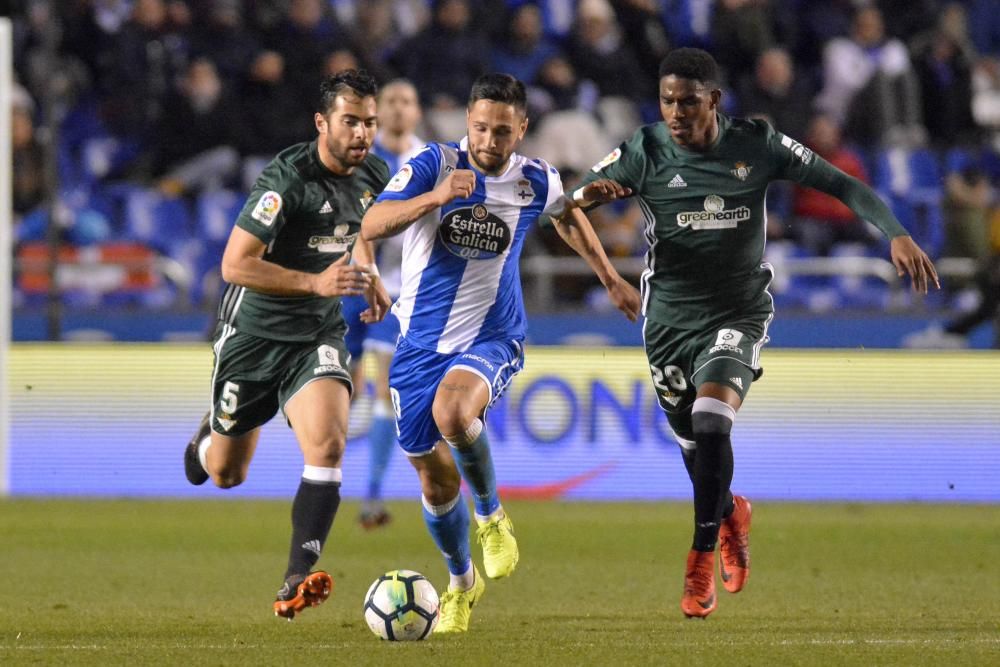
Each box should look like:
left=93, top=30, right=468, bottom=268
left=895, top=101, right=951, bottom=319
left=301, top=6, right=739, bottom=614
left=577, top=48, right=938, bottom=617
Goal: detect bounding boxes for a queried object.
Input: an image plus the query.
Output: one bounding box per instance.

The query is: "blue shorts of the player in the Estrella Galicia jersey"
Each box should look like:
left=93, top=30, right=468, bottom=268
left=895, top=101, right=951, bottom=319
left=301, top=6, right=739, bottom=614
left=389, top=338, right=524, bottom=456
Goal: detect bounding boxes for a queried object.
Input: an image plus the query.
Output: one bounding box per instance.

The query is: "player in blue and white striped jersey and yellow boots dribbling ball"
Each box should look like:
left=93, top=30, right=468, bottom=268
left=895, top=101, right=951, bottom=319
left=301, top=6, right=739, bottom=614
left=362, top=74, right=640, bottom=632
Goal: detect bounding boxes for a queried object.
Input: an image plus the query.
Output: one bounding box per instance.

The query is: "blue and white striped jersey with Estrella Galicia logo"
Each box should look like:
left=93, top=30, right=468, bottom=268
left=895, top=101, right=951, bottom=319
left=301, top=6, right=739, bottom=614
left=378, top=139, right=565, bottom=354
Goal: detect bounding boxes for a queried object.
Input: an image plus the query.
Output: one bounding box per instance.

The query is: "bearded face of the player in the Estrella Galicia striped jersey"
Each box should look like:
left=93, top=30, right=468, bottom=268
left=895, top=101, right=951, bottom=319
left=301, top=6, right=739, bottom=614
left=468, top=100, right=528, bottom=174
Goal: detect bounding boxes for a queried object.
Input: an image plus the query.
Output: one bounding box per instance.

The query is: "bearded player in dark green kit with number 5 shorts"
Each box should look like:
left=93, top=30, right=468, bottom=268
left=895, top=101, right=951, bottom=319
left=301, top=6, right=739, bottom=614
left=184, top=70, right=390, bottom=620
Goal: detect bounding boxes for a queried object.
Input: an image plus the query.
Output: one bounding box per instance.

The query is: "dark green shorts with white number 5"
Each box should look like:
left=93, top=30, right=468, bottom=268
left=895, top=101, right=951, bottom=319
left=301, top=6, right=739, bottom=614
left=212, top=324, right=354, bottom=436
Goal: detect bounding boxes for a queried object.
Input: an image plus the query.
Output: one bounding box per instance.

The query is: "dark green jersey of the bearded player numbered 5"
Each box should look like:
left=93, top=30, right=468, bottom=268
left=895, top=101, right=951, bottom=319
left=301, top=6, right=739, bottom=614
left=219, top=141, right=389, bottom=341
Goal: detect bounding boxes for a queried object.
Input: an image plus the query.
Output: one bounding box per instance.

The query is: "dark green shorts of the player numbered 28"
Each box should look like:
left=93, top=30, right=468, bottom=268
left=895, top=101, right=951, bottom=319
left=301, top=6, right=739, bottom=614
left=642, top=313, right=771, bottom=422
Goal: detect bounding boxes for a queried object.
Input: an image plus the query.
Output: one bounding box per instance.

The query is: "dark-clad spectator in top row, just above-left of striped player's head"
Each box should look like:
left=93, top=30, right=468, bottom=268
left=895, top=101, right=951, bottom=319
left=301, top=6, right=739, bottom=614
left=393, top=0, right=489, bottom=109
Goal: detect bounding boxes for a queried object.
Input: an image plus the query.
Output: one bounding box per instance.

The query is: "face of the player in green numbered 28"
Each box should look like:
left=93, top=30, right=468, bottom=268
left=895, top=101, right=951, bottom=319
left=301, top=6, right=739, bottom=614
left=660, top=74, right=721, bottom=149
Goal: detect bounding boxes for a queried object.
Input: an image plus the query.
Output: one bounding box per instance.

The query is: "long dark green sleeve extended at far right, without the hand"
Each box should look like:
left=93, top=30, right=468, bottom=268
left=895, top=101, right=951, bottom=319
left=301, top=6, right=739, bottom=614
left=767, top=126, right=909, bottom=239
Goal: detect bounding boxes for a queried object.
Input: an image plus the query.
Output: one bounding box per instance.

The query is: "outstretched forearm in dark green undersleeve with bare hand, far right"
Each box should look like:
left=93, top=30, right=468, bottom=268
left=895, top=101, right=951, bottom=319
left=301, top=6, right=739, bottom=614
left=802, top=165, right=941, bottom=294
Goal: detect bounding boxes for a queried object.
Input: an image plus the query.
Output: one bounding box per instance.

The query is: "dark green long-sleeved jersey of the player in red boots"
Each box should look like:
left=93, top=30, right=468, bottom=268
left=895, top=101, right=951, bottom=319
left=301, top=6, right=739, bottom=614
left=581, top=114, right=906, bottom=329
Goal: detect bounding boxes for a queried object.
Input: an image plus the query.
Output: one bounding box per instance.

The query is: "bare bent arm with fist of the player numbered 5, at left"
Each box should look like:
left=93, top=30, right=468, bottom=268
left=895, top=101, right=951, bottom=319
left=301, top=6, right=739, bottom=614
left=222, top=227, right=371, bottom=296
